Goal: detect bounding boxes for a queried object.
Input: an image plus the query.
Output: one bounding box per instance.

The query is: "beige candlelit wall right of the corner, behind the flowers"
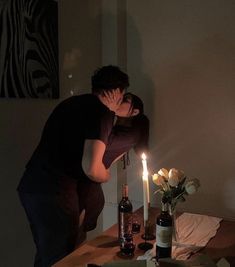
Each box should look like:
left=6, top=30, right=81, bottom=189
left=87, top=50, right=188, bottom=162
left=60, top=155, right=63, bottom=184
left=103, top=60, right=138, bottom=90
left=127, top=0, right=235, bottom=219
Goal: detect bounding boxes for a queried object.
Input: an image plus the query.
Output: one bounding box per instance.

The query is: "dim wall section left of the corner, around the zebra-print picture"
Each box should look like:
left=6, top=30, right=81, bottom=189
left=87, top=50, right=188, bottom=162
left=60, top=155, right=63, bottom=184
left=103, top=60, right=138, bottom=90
left=0, top=0, right=101, bottom=267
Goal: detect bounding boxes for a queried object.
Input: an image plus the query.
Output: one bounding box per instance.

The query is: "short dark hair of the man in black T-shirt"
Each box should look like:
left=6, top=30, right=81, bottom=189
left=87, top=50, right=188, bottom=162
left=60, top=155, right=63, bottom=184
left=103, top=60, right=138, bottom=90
left=91, top=65, right=129, bottom=94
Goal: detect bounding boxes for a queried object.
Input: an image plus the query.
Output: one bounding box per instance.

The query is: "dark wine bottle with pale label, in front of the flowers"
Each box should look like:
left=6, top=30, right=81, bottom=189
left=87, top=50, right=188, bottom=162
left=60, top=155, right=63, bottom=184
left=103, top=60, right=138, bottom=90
left=156, top=202, right=173, bottom=261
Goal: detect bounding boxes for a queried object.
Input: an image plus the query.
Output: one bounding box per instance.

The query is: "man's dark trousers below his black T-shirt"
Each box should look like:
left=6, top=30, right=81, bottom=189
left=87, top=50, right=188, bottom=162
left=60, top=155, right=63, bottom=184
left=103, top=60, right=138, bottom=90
left=19, top=175, right=80, bottom=267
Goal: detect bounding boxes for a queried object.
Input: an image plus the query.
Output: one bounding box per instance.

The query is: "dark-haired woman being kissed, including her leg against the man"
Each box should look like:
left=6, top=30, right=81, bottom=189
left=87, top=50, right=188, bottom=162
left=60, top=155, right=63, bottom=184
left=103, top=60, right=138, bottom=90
left=78, top=93, right=149, bottom=238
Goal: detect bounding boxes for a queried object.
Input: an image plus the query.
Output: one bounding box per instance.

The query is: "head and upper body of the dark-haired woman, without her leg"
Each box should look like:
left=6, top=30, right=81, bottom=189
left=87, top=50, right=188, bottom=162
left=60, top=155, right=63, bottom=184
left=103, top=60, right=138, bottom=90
left=103, top=93, right=149, bottom=168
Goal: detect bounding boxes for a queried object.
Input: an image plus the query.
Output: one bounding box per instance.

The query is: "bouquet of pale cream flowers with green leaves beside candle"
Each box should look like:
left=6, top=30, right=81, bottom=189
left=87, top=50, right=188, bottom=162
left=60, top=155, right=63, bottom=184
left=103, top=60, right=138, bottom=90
left=152, top=168, right=200, bottom=214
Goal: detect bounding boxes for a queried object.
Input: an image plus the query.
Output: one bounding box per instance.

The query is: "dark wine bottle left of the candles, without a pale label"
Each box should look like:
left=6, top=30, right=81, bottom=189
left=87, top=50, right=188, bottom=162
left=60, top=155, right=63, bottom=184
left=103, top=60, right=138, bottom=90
left=118, top=184, right=135, bottom=255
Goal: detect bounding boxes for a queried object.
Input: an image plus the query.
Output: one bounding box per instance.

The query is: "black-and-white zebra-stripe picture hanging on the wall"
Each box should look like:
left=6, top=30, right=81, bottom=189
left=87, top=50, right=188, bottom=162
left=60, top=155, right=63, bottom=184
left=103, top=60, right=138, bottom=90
left=0, top=0, right=59, bottom=98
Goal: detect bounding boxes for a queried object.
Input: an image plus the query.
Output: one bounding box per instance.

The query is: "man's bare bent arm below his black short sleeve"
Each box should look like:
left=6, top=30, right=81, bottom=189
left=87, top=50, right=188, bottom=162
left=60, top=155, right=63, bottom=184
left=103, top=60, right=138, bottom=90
left=82, top=139, right=110, bottom=183
